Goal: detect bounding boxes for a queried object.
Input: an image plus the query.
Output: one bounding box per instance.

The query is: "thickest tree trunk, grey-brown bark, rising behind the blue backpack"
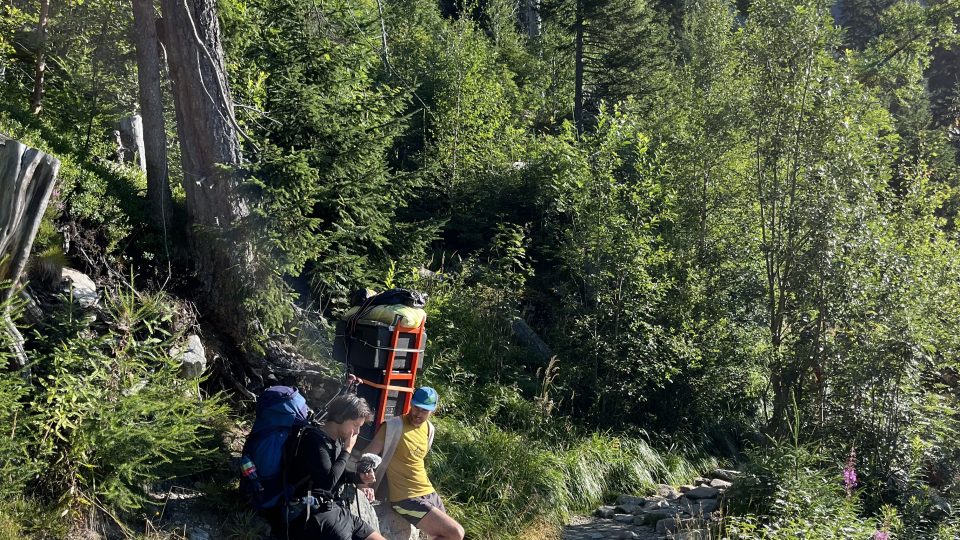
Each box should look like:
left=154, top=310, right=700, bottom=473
left=162, top=0, right=253, bottom=343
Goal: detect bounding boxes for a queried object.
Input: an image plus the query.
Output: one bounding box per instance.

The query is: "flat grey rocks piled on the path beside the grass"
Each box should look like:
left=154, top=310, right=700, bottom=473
left=594, top=469, right=740, bottom=540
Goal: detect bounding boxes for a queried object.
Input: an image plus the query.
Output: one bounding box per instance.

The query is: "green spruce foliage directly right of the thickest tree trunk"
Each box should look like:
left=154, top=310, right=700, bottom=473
left=224, top=0, right=429, bottom=300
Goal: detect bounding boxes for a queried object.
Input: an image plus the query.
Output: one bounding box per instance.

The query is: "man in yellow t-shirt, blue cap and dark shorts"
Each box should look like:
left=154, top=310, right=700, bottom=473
left=365, top=386, right=464, bottom=540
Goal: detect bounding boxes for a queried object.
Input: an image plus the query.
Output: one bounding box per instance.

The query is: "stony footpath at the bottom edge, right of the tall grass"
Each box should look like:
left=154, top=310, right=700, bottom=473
left=563, top=469, right=739, bottom=540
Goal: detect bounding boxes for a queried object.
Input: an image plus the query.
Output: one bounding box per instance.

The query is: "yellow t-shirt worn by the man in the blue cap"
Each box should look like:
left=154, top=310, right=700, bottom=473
left=374, top=416, right=436, bottom=502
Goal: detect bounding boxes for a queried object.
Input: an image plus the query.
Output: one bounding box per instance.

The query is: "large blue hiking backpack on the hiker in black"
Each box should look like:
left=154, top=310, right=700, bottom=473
left=240, top=386, right=310, bottom=510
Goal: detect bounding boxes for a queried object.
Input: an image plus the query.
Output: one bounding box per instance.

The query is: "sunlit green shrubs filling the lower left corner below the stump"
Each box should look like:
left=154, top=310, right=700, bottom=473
left=0, top=278, right=231, bottom=537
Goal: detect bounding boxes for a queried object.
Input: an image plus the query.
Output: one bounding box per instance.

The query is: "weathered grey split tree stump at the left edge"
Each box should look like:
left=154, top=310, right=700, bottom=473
left=0, top=134, right=60, bottom=367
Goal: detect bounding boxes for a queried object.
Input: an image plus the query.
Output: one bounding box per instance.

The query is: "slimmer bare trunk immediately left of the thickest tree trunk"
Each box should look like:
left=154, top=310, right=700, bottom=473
left=133, top=0, right=173, bottom=231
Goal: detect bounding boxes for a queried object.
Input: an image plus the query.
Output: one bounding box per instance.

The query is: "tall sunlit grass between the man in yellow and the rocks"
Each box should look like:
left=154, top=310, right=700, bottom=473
left=430, top=419, right=715, bottom=539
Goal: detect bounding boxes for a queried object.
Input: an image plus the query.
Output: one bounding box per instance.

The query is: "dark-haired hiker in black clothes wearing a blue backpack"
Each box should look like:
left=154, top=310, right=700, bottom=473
left=241, top=386, right=386, bottom=540
